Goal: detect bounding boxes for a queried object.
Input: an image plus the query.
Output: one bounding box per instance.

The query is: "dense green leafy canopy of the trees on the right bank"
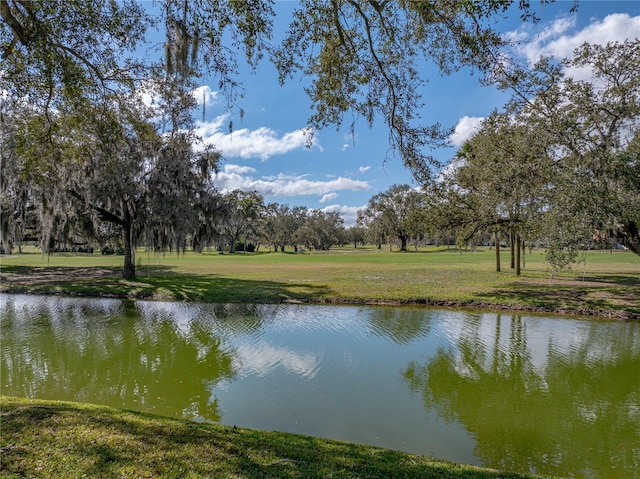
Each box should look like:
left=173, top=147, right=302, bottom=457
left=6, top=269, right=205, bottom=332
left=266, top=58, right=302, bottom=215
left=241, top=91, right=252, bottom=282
left=441, top=40, right=640, bottom=270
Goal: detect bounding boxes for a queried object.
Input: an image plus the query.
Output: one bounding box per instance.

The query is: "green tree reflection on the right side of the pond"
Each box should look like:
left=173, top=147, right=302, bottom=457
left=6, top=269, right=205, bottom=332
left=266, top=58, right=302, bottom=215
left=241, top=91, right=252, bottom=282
left=404, top=315, right=640, bottom=477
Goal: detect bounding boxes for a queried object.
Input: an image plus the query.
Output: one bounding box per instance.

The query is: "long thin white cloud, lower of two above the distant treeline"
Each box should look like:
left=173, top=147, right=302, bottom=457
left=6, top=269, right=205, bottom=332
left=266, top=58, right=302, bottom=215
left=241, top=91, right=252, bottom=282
left=214, top=164, right=370, bottom=197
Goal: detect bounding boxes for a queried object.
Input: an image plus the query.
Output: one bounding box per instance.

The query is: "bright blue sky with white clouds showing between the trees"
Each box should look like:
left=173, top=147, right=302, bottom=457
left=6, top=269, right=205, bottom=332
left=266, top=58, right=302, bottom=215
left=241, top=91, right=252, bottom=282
left=176, top=0, right=640, bottom=226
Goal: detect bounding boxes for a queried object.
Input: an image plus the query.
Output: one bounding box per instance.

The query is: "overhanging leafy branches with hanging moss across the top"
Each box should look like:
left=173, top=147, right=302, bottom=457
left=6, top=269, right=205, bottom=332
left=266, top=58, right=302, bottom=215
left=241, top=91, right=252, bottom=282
left=0, top=0, right=575, bottom=173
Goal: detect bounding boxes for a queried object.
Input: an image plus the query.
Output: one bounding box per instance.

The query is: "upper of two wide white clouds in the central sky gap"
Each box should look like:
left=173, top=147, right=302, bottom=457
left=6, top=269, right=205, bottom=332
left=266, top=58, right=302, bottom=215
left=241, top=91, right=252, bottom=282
left=196, top=115, right=322, bottom=161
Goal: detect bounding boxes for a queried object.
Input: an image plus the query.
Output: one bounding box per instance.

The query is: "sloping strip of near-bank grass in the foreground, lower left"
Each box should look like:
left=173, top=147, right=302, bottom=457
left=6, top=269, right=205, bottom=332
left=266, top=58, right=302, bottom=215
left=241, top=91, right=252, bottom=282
left=0, top=397, right=552, bottom=479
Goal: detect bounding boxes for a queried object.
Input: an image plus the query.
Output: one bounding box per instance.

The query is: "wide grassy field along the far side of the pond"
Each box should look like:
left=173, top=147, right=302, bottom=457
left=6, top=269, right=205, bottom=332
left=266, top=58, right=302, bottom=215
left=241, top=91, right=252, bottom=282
left=0, top=247, right=640, bottom=319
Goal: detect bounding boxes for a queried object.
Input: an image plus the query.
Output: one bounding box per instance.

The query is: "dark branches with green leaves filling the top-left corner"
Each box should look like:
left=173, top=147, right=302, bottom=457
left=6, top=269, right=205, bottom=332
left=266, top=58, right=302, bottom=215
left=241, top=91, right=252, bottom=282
left=0, top=0, right=151, bottom=111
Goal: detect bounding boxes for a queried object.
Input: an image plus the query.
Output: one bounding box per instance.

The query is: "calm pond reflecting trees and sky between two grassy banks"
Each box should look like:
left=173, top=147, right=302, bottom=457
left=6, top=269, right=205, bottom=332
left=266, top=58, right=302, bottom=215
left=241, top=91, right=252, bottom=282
left=0, top=295, right=640, bottom=478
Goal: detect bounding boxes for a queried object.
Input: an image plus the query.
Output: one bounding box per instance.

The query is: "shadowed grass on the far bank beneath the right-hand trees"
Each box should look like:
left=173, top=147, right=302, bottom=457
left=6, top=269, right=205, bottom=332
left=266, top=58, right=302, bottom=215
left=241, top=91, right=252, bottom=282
left=477, top=274, right=640, bottom=319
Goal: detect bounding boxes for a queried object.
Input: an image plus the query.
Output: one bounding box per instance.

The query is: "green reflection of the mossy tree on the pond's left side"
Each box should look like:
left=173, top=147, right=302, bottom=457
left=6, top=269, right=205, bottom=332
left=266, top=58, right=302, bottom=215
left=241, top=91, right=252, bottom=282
left=1, top=298, right=272, bottom=421
